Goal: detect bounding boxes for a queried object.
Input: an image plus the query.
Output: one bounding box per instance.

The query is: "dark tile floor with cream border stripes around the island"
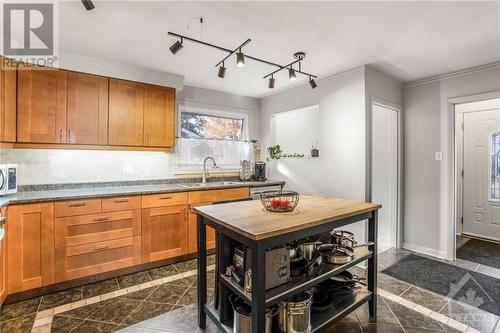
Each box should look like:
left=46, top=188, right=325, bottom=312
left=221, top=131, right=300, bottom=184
left=0, top=249, right=500, bottom=333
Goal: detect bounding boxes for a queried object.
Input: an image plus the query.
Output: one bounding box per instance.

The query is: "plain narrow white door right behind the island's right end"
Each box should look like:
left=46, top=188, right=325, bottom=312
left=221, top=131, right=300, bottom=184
left=372, top=104, right=398, bottom=251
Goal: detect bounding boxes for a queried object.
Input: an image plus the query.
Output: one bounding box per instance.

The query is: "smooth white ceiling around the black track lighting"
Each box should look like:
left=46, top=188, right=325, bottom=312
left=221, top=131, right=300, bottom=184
left=59, top=0, right=500, bottom=97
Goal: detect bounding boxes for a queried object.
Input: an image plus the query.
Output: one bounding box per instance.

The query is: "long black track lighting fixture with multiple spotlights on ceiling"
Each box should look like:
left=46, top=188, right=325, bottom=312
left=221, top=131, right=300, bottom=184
left=168, top=32, right=317, bottom=89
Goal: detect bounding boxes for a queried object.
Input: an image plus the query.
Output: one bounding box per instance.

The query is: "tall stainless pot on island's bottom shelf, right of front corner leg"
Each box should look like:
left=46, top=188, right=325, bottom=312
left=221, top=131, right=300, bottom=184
left=278, top=291, right=312, bottom=333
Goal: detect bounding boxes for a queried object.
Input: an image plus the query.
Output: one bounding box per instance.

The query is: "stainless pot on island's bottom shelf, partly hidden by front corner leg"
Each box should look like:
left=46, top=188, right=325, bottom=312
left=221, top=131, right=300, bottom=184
left=229, top=294, right=278, bottom=333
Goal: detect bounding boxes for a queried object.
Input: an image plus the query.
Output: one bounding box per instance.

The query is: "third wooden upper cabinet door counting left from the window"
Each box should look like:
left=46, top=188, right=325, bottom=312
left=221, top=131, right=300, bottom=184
left=67, top=73, right=109, bottom=145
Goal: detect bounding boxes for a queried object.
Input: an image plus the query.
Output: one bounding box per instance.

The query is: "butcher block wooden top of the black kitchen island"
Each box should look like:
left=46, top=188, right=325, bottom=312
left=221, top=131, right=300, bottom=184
left=194, top=195, right=382, bottom=240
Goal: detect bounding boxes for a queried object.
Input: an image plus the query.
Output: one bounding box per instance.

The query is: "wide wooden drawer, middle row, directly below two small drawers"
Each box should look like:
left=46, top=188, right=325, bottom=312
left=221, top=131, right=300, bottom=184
left=55, top=209, right=141, bottom=248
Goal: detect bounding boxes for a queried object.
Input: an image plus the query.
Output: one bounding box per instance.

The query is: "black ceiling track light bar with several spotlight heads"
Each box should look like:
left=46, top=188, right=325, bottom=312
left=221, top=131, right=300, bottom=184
left=168, top=31, right=317, bottom=89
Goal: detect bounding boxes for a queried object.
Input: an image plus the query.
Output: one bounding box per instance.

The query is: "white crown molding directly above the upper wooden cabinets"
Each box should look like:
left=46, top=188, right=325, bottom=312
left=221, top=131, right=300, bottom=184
left=59, top=51, right=184, bottom=91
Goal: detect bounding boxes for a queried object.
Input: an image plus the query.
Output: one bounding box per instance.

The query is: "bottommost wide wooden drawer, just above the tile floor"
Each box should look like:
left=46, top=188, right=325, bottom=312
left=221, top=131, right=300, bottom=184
left=55, top=236, right=141, bottom=282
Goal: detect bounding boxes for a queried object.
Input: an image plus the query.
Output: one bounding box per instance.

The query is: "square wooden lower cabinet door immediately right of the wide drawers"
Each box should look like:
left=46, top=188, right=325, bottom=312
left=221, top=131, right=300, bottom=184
left=142, top=205, right=188, bottom=263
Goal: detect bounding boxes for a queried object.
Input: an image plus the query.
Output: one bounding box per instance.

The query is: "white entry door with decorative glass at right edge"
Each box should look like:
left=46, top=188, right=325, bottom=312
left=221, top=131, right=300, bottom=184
left=463, top=109, right=500, bottom=240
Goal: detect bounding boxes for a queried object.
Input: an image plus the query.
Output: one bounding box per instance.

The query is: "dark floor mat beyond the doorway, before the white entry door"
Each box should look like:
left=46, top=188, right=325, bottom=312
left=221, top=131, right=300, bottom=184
left=457, top=239, right=500, bottom=269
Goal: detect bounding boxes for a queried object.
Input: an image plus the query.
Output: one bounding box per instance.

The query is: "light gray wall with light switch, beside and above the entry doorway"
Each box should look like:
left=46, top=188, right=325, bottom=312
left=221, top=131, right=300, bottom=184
left=403, top=64, right=500, bottom=257
